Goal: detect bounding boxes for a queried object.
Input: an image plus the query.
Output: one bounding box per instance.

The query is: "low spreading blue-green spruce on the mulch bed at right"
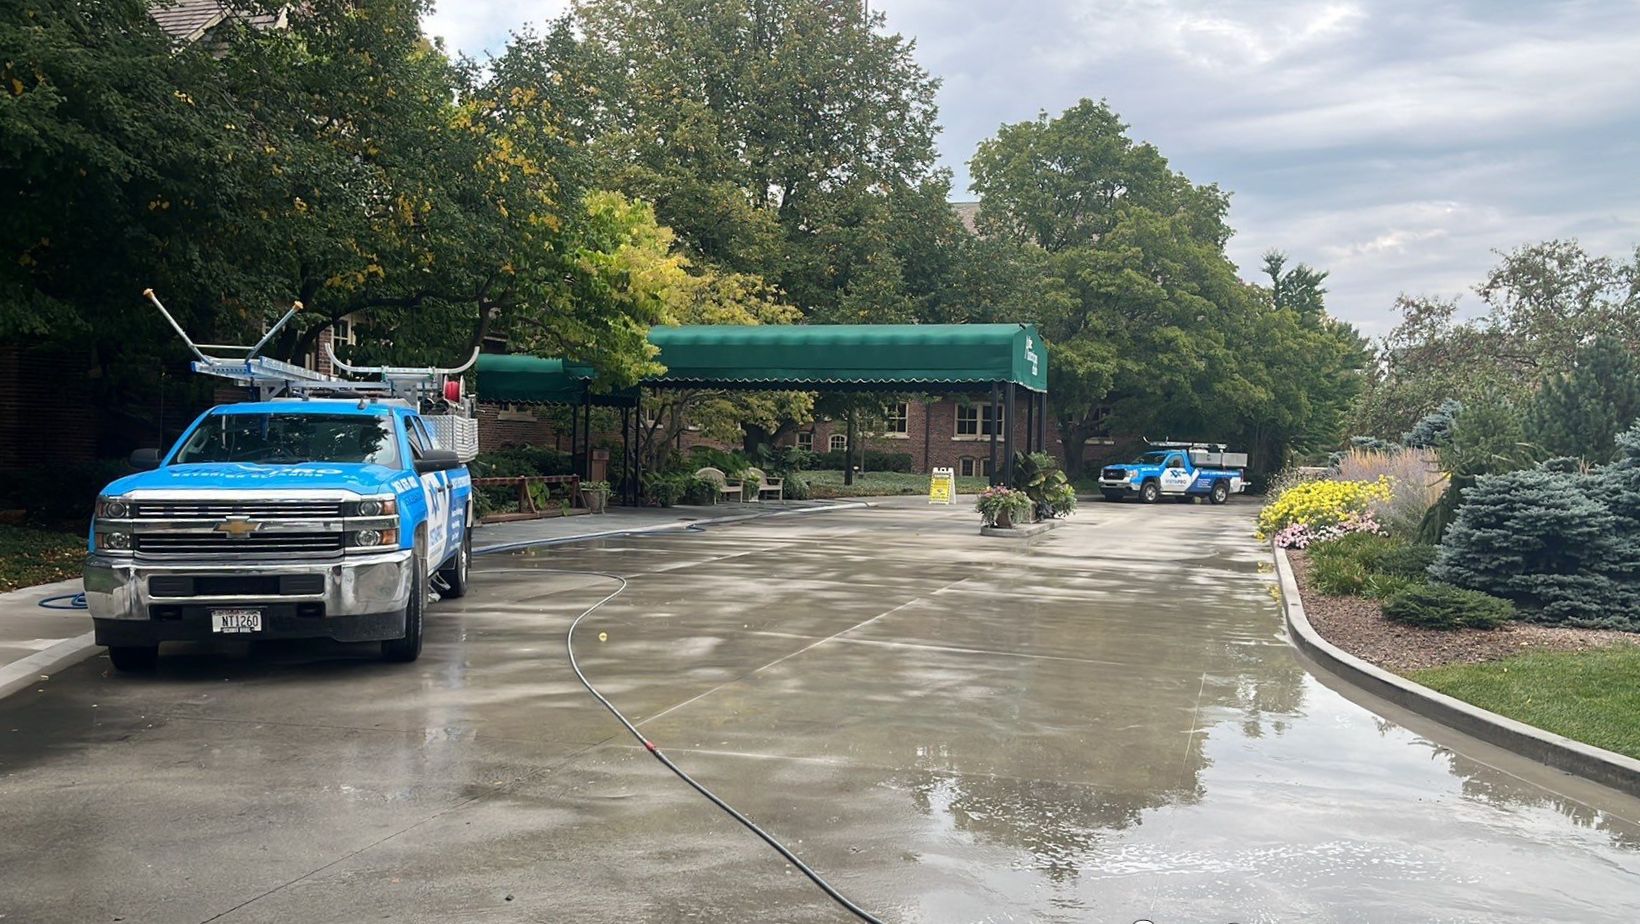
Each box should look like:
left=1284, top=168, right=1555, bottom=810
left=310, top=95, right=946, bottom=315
left=1430, top=466, right=1640, bottom=629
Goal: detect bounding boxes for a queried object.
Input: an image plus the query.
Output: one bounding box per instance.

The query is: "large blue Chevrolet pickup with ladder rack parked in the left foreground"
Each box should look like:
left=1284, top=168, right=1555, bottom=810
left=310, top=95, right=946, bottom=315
left=85, top=290, right=477, bottom=671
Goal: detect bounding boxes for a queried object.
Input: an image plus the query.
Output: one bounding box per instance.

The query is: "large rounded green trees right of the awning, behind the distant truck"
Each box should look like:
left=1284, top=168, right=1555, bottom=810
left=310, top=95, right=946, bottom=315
left=971, top=100, right=1366, bottom=478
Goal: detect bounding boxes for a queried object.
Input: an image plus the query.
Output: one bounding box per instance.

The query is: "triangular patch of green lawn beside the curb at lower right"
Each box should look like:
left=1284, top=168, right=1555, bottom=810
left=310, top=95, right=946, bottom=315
left=1412, top=645, right=1640, bottom=758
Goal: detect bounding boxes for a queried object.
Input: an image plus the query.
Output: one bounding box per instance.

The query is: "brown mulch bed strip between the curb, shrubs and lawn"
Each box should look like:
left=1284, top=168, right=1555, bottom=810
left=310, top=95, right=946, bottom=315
left=1287, top=550, right=1637, bottom=675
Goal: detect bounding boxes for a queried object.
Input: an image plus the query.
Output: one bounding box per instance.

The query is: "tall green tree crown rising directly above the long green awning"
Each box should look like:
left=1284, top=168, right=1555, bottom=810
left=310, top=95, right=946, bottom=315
left=574, top=0, right=954, bottom=320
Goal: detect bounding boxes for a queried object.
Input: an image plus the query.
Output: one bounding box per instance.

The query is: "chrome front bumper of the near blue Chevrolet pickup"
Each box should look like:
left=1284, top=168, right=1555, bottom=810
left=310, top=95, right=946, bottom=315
left=85, top=548, right=415, bottom=619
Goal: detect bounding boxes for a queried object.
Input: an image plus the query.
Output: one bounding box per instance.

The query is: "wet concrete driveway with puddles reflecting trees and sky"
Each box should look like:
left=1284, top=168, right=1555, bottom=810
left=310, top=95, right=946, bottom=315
left=0, top=501, right=1640, bottom=924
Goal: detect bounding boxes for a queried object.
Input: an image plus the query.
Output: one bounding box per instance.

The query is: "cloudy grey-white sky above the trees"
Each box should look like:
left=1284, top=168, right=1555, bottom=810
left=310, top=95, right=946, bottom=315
left=428, top=0, right=1640, bottom=335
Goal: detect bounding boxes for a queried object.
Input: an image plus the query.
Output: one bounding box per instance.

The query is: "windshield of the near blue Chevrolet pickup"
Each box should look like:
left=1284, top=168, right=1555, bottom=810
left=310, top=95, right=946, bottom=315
left=172, top=414, right=399, bottom=468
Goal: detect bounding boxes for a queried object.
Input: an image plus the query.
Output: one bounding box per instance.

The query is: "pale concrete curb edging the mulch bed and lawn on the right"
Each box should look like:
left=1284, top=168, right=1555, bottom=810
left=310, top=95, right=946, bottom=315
left=1271, top=543, right=1640, bottom=796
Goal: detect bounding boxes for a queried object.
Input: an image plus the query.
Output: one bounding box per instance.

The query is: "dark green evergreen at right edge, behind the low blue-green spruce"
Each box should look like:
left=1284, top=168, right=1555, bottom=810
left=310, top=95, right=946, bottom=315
left=1527, top=336, right=1640, bottom=464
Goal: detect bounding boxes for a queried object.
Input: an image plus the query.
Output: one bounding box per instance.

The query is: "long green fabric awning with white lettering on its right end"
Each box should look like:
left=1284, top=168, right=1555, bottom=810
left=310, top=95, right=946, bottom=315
left=645, top=323, right=1048, bottom=392
